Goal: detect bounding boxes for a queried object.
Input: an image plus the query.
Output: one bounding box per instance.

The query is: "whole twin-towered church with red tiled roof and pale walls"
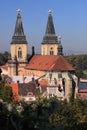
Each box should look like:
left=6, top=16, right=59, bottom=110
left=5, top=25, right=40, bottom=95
left=1, top=9, right=78, bottom=100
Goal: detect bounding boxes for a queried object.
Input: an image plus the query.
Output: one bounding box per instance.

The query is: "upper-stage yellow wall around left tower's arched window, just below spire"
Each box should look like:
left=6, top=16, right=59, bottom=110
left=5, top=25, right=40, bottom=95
left=11, top=44, right=28, bottom=60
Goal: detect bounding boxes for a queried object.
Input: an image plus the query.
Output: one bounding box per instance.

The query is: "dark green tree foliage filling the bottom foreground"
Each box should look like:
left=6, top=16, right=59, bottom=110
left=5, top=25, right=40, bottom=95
left=0, top=97, right=87, bottom=130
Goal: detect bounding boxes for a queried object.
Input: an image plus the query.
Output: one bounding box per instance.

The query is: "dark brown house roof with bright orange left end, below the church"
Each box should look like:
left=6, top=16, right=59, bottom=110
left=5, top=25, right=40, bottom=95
left=6, top=83, right=39, bottom=102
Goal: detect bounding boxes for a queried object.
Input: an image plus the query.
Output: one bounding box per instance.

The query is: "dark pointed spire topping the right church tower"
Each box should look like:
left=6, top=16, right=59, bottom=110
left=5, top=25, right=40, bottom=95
left=42, top=10, right=58, bottom=44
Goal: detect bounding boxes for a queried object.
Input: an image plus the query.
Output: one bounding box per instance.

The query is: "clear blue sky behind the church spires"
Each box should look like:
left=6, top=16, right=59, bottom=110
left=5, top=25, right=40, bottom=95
left=0, top=0, right=87, bottom=54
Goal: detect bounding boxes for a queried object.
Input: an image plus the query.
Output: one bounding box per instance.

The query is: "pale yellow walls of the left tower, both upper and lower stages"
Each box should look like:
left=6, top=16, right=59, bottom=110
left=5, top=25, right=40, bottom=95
left=8, top=44, right=28, bottom=76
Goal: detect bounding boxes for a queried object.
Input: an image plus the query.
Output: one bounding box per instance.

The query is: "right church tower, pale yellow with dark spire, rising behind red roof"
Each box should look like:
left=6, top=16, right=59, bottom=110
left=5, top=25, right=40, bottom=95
left=41, top=10, right=63, bottom=55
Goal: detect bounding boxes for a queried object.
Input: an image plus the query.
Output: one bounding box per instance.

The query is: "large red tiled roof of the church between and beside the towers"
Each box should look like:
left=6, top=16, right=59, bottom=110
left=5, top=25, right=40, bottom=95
left=26, top=55, right=75, bottom=71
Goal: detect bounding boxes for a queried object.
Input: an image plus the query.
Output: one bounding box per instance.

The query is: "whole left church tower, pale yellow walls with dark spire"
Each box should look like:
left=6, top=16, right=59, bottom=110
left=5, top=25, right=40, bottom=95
left=8, top=9, right=28, bottom=76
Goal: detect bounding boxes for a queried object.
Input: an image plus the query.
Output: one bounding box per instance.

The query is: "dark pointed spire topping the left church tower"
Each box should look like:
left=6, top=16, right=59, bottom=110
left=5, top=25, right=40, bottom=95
left=11, top=9, right=27, bottom=44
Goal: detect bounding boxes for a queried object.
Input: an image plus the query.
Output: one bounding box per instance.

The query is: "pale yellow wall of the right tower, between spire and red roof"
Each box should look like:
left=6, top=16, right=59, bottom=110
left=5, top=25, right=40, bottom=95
left=41, top=44, right=58, bottom=55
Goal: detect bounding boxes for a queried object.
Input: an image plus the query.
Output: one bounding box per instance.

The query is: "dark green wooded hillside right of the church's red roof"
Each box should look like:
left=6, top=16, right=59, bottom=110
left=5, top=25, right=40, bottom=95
left=65, top=54, right=87, bottom=78
